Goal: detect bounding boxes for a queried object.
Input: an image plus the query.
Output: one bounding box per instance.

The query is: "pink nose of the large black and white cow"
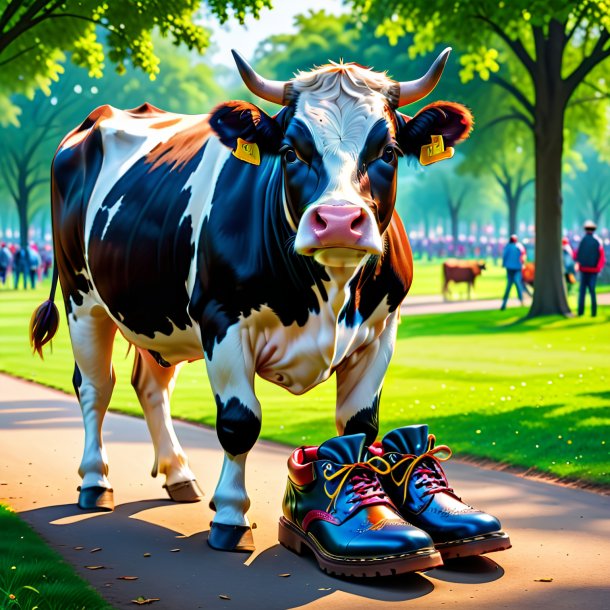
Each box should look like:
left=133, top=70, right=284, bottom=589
left=311, top=205, right=366, bottom=246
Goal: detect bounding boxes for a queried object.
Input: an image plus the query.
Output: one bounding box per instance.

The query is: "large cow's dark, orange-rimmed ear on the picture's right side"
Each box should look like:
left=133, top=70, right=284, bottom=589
left=397, top=102, right=474, bottom=164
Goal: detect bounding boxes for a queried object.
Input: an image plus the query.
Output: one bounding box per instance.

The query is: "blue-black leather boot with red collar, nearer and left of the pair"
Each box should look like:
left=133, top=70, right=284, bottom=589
left=279, top=434, right=442, bottom=576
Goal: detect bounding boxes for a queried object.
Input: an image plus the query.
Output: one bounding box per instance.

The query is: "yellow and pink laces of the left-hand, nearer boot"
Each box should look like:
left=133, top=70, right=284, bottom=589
left=324, top=455, right=392, bottom=512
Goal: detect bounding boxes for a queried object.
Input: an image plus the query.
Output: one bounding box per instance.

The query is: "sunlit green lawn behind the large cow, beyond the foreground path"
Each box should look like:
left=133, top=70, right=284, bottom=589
left=0, top=280, right=610, bottom=484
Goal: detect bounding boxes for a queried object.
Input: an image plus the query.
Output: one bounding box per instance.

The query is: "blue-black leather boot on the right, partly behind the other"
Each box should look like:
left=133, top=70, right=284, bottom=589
left=369, top=424, right=511, bottom=560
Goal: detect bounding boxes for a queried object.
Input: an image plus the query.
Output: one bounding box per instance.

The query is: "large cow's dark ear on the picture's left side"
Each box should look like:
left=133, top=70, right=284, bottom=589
left=210, top=101, right=283, bottom=153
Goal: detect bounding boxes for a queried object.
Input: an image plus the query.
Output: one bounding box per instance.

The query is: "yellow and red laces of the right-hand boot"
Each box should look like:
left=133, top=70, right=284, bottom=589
left=390, top=434, right=453, bottom=502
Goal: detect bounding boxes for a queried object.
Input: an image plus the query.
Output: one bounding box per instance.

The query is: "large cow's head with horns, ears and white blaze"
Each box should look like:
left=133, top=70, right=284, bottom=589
left=210, top=49, right=472, bottom=266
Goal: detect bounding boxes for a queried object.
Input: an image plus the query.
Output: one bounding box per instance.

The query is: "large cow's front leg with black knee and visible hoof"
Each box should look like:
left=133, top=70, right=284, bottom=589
left=206, top=331, right=261, bottom=552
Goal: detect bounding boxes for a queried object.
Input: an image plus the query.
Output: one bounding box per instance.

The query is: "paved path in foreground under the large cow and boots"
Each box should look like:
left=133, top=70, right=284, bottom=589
left=0, top=375, right=610, bottom=610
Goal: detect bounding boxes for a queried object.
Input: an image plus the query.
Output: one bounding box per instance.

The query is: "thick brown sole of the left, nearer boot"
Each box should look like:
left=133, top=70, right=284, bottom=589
left=278, top=517, right=443, bottom=578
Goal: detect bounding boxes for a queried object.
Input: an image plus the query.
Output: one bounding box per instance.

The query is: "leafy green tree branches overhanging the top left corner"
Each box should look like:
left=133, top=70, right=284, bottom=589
left=0, top=0, right=271, bottom=125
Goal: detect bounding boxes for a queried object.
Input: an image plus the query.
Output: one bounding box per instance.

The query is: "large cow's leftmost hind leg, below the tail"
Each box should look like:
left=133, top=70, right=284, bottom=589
left=68, top=304, right=116, bottom=510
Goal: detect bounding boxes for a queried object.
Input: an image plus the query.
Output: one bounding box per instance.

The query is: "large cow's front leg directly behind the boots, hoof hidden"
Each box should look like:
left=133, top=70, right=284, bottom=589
left=336, top=311, right=398, bottom=445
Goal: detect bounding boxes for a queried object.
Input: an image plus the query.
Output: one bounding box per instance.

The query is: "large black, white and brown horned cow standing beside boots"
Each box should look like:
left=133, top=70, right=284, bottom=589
left=31, top=49, right=472, bottom=551
